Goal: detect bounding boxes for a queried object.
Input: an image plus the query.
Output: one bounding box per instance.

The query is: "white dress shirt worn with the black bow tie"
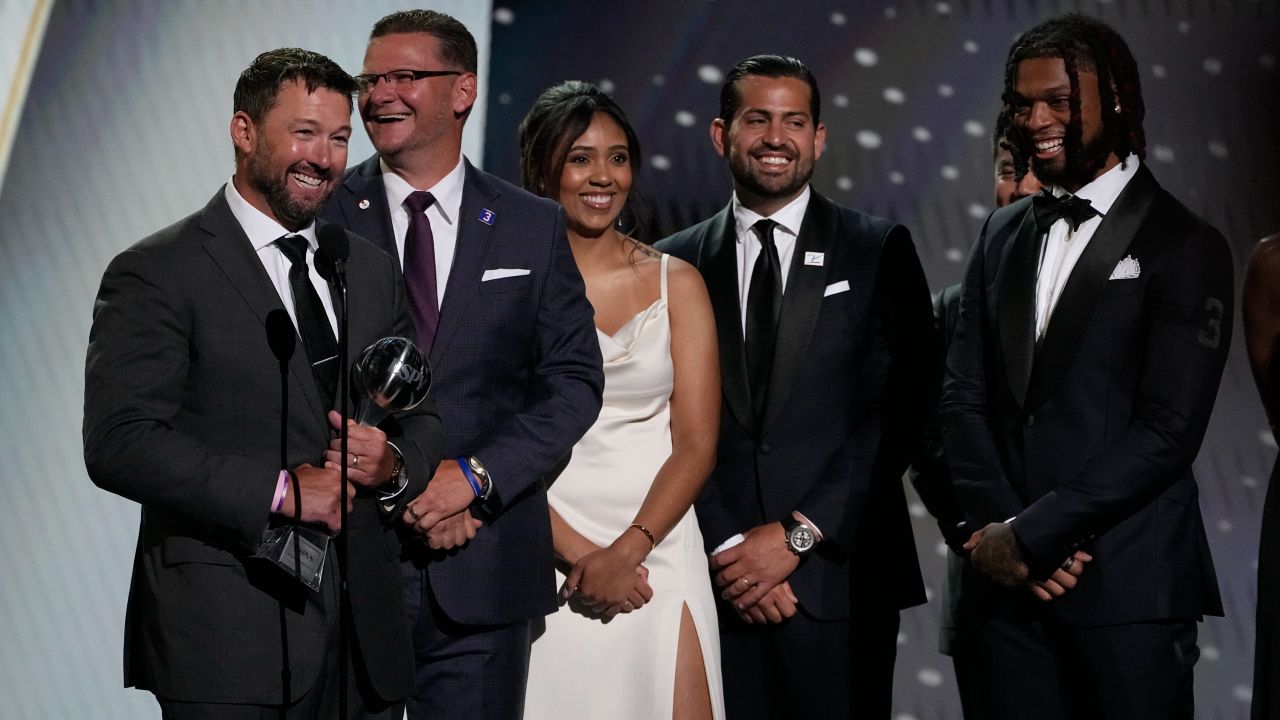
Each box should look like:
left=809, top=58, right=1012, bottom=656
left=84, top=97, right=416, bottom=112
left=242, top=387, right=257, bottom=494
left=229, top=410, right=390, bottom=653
left=1036, top=155, right=1138, bottom=341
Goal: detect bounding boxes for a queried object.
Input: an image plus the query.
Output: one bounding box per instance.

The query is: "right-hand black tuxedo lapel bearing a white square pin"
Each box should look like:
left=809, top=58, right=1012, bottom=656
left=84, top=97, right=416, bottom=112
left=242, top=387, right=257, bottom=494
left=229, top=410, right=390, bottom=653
left=760, top=192, right=838, bottom=434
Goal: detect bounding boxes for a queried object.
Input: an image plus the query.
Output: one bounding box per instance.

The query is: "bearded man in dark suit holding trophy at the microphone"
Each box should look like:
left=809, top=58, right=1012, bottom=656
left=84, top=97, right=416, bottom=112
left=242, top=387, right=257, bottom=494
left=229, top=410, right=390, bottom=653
left=84, top=49, right=444, bottom=719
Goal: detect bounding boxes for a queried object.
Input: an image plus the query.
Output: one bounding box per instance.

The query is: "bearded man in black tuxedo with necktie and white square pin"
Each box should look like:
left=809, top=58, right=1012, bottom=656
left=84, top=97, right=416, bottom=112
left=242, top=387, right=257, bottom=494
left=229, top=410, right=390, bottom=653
left=658, top=55, right=937, bottom=719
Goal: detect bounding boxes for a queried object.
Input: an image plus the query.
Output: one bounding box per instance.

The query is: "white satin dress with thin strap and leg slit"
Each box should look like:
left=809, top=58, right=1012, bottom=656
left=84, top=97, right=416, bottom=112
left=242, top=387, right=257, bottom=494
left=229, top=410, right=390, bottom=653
left=525, top=255, right=724, bottom=720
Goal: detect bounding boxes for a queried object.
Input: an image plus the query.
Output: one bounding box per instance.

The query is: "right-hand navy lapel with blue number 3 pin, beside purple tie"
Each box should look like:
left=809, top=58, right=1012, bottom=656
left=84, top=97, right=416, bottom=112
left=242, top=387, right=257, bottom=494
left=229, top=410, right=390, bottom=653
left=430, top=163, right=491, bottom=364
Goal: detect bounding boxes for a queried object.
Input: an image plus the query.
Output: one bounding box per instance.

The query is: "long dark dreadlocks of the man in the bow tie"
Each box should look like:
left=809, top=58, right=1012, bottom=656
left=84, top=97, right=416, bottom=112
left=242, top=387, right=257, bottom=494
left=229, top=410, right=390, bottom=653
left=996, top=13, right=1147, bottom=179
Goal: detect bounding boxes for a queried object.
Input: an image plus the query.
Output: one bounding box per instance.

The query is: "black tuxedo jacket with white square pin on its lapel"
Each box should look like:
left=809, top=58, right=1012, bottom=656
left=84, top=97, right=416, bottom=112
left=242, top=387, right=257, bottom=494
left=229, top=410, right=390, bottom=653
left=658, top=192, right=936, bottom=619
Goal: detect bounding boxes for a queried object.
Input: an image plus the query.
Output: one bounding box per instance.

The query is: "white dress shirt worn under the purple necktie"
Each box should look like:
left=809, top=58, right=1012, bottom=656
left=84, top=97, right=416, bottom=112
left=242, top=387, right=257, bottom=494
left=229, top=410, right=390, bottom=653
left=379, top=155, right=466, bottom=307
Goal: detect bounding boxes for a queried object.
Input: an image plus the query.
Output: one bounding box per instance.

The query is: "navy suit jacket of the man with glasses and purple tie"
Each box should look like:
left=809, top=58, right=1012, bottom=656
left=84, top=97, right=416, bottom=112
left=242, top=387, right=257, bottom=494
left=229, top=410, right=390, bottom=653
left=323, top=155, right=604, bottom=624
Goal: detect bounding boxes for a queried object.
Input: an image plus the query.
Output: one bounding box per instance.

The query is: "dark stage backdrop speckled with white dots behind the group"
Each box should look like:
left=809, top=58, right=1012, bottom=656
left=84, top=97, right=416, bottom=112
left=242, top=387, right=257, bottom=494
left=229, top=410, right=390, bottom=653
left=485, top=0, right=1280, bottom=720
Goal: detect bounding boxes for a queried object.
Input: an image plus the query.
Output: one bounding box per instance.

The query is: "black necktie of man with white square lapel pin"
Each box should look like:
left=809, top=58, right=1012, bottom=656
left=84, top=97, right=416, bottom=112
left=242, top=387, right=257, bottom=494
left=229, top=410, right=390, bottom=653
left=746, top=215, right=782, bottom=428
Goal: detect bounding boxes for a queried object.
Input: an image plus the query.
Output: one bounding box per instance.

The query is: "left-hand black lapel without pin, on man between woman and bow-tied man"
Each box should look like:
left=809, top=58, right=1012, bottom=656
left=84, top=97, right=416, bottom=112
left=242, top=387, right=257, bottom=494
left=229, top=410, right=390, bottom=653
left=700, top=208, right=755, bottom=428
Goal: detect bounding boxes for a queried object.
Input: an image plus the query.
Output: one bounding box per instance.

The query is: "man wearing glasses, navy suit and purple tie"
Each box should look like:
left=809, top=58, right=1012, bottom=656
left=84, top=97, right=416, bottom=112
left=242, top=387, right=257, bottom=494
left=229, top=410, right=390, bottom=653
left=324, top=10, right=604, bottom=719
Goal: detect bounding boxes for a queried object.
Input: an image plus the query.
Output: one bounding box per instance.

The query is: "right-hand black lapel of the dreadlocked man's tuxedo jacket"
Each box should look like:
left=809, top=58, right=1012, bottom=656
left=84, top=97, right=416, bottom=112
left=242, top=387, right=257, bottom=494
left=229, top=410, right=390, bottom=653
left=1025, top=165, right=1156, bottom=407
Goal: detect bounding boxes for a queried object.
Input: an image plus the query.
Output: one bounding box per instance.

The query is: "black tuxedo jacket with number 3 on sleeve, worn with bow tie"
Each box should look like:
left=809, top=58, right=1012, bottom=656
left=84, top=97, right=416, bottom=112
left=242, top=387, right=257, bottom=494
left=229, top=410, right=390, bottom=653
left=942, top=167, right=1234, bottom=625
